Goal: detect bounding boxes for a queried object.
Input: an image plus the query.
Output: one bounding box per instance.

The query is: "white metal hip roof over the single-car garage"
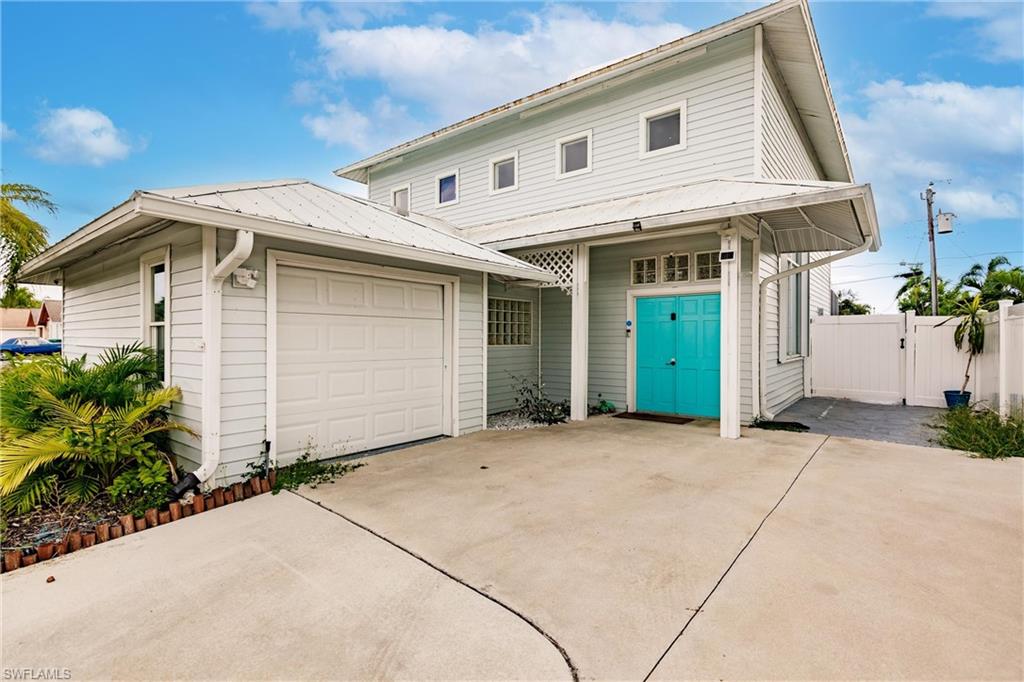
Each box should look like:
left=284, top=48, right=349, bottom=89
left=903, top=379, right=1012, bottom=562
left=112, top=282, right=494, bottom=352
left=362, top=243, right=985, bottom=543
left=22, top=179, right=553, bottom=282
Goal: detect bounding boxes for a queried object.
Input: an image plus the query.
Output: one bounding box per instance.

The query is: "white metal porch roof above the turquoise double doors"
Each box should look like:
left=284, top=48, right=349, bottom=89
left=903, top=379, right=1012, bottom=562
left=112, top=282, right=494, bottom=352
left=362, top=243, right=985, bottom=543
left=464, top=179, right=881, bottom=253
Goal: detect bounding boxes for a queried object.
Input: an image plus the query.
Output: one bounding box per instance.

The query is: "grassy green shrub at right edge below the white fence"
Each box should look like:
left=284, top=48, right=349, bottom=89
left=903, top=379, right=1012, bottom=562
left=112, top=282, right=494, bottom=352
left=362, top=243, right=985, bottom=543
left=937, top=408, right=1024, bottom=459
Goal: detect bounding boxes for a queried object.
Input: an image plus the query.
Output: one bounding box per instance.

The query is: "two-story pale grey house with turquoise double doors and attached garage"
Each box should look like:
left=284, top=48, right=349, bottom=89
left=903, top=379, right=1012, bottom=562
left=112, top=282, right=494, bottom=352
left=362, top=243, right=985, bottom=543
left=18, top=0, right=880, bottom=489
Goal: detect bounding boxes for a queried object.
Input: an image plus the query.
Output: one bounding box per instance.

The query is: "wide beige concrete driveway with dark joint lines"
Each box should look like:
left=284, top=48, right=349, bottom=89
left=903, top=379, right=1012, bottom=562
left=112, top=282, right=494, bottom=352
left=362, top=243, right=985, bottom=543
left=3, top=418, right=1024, bottom=679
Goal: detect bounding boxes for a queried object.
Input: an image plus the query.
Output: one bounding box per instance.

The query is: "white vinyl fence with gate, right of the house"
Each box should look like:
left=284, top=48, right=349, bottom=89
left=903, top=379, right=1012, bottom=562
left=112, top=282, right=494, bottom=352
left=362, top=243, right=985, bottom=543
left=810, top=301, right=1024, bottom=415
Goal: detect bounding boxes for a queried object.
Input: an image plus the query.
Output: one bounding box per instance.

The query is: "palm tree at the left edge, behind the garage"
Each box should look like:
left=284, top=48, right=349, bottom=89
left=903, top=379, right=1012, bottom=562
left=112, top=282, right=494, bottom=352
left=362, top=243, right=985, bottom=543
left=0, top=182, right=57, bottom=297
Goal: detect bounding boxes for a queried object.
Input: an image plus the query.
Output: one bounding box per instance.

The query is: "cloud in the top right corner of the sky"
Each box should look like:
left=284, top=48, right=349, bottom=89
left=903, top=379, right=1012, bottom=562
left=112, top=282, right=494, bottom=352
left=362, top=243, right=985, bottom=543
left=928, top=2, right=1024, bottom=61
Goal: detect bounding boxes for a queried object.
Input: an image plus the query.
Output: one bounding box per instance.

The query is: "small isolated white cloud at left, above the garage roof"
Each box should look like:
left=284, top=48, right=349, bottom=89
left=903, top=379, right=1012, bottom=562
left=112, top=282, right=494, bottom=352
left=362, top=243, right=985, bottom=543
left=34, top=106, right=132, bottom=166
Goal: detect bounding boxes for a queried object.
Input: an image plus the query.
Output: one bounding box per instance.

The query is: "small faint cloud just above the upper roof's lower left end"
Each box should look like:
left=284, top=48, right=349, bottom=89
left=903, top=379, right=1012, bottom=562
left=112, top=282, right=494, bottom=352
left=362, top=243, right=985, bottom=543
left=302, top=96, right=419, bottom=153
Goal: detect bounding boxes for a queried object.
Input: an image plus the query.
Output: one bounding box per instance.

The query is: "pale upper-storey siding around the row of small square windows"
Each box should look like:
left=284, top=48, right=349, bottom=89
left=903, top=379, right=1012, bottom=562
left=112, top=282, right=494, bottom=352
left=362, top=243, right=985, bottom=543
left=370, top=31, right=755, bottom=226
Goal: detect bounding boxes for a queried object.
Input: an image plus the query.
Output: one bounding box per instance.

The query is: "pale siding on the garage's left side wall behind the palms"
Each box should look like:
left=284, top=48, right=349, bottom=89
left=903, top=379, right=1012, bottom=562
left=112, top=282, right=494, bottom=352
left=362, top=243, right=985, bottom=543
left=63, top=223, right=202, bottom=464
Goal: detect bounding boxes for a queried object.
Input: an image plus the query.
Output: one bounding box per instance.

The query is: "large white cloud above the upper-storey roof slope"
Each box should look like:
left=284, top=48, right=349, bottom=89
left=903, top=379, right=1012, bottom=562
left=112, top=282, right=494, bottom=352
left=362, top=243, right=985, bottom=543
left=318, top=5, right=690, bottom=121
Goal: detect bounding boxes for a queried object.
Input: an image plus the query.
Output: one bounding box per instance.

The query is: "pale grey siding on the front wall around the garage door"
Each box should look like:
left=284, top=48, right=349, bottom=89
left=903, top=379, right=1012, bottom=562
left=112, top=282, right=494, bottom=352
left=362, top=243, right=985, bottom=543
left=211, top=232, right=484, bottom=480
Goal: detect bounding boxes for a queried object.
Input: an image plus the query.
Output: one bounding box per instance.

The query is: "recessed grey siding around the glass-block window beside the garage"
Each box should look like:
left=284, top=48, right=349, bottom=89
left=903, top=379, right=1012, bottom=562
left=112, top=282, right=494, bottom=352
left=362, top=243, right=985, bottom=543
left=487, top=280, right=541, bottom=415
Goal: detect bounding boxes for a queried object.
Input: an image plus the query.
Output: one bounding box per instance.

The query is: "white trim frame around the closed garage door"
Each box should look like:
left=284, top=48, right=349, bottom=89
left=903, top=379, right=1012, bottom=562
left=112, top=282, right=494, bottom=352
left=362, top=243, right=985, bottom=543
left=266, top=249, right=460, bottom=464
